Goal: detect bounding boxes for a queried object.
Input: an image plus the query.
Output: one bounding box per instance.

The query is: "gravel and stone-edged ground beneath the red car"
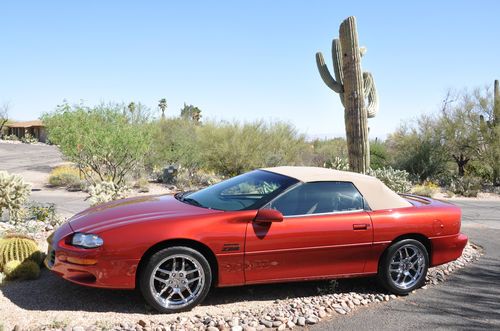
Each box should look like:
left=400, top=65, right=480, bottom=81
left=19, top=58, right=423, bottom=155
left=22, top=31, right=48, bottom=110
left=0, top=245, right=481, bottom=331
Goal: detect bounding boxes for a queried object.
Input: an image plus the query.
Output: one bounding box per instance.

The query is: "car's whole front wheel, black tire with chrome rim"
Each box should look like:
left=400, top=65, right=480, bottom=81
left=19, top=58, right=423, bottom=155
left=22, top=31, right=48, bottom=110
left=139, top=246, right=212, bottom=313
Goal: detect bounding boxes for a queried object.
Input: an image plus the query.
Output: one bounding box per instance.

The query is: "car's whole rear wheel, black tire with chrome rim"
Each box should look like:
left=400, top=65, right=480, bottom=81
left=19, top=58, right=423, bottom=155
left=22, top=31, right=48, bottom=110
left=378, top=239, right=429, bottom=295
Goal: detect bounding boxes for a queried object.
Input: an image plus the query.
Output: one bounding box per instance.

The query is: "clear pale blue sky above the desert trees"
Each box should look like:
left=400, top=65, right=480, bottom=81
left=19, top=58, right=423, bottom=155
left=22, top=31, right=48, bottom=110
left=0, top=0, right=500, bottom=137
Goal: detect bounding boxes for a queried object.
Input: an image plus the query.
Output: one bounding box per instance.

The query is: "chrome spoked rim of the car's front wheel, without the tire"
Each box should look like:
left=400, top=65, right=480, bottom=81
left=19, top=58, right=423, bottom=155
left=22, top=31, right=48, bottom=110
left=149, top=254, right=205, bottom=308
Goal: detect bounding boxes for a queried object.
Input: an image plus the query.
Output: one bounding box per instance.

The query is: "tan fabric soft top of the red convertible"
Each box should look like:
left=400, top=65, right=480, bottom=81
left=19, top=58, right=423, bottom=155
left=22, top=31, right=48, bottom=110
left=262, top=167, right=412, bottom=210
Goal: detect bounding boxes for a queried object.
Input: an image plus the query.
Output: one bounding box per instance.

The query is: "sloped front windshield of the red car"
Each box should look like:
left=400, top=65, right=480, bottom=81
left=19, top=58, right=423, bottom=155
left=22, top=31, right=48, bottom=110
left=176, top=170, right=298, bottom=211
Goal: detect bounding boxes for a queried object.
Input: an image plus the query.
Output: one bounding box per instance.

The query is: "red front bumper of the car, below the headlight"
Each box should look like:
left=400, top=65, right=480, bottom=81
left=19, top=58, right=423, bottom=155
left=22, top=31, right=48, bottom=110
left=44, top=225, right=139, bottom=289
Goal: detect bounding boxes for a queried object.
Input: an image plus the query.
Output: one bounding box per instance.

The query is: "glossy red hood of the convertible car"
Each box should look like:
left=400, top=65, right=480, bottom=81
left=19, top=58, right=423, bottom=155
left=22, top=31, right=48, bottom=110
left=69, top=195, right=220, bottom=233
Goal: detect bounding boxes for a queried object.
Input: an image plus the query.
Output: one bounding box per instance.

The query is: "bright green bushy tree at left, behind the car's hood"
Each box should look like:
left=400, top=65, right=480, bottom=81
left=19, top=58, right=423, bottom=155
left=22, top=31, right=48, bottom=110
left=42, top=104, right=152, bottom=186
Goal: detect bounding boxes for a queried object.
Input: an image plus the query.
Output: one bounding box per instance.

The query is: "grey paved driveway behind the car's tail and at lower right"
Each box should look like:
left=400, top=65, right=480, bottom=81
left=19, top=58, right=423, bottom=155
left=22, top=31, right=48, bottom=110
left=311, top=200, right=500, bottom=330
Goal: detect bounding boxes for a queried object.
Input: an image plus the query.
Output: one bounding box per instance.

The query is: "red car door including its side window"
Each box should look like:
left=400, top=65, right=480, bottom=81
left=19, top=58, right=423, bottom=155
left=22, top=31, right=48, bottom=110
left=245, top=182, right=373, bottom=283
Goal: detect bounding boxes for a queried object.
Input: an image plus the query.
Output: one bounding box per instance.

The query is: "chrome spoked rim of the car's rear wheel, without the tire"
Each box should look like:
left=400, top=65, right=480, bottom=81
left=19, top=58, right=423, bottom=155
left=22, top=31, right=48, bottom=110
left=389, top=244, right=425, bottom=290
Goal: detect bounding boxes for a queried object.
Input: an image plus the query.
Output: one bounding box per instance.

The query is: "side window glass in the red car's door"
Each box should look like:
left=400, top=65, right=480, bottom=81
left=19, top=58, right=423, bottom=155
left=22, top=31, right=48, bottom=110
left=267, top=182, right=364, bottom=216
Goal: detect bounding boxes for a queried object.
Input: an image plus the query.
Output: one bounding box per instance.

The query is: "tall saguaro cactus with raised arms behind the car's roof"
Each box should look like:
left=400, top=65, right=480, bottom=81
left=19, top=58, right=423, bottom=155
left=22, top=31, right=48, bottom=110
left=316, top=16, right=378, bottom=173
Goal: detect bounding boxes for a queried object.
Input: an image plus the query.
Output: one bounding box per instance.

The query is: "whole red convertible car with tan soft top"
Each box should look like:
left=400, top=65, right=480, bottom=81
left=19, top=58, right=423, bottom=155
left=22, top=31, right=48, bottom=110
left=46, top=167, right=467, bottom=312
